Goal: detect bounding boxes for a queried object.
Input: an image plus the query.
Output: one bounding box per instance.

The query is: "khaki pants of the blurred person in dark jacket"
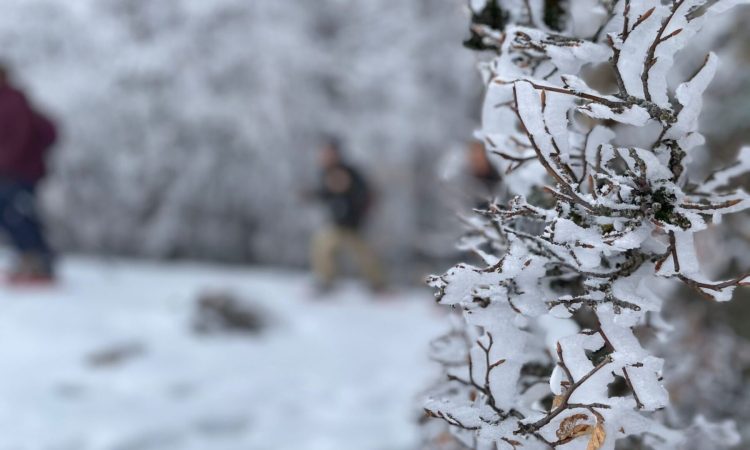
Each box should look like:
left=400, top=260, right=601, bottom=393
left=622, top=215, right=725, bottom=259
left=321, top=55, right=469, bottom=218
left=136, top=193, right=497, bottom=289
left=311, top=227, right=384, bottom=288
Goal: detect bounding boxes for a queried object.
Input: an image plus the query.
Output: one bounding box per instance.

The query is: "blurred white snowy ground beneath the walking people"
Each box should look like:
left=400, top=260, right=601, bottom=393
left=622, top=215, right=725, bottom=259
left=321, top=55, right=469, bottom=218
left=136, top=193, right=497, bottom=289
left=0, top=259, right=445, bottom=450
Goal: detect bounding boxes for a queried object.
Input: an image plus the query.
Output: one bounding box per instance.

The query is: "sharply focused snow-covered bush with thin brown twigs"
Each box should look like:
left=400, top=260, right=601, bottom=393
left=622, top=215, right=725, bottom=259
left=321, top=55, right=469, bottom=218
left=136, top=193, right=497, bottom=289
left=426, top=0, right=750, bottom=450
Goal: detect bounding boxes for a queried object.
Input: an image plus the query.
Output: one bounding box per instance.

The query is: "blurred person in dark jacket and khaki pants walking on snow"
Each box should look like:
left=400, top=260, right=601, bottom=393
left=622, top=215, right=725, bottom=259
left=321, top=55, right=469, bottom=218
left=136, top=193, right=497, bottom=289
left=311, top=139, right=384, bottom=290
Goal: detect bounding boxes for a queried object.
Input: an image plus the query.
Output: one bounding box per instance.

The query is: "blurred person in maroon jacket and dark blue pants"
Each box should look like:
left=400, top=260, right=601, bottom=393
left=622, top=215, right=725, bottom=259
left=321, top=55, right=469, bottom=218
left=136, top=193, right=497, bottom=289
left=0, top=65, right=57, bottom=282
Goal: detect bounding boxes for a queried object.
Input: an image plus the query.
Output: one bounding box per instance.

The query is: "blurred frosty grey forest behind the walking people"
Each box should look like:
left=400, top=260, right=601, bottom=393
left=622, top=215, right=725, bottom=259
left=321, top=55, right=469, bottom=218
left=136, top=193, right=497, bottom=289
left=0, top=0, right=480, bottom=274
